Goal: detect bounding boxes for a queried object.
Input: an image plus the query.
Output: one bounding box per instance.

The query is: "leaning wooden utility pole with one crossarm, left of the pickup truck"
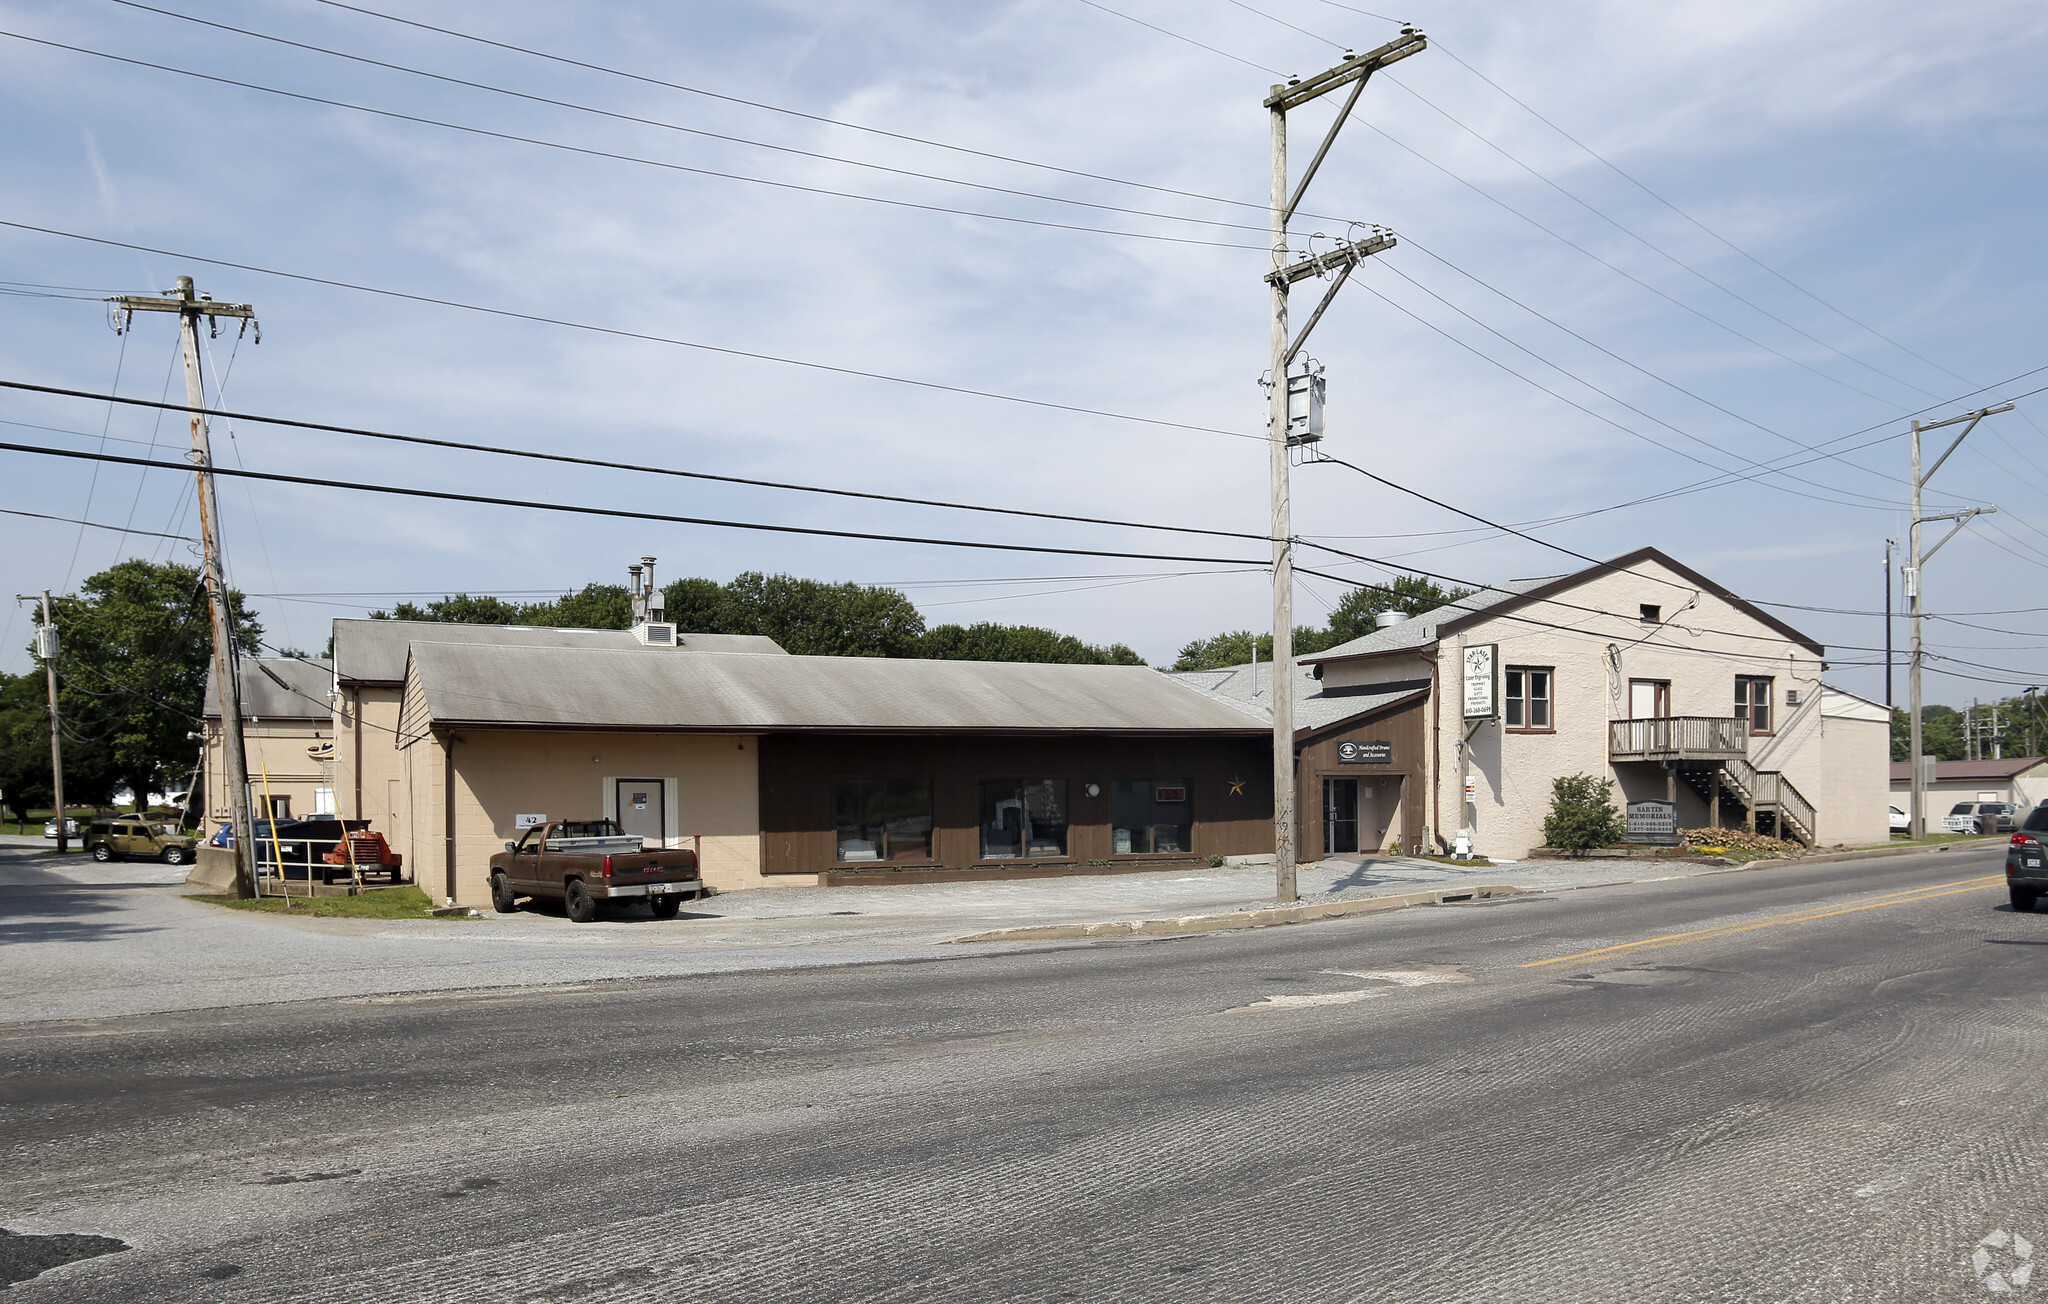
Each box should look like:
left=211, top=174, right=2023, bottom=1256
left=113, top=276, right=262, bottom=899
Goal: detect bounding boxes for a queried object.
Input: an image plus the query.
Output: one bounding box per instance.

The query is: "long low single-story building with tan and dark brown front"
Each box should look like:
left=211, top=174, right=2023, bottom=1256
left=387, top=639, right=1272, bottom=903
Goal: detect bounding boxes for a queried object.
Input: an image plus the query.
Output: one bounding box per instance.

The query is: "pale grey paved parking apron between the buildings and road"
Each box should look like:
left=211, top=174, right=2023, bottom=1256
left=0, top=839, right=1957, bottom=1024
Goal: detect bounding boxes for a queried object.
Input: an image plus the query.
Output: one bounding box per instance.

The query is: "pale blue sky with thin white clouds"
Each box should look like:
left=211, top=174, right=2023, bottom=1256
left=0, top=0, right=2048, bottom=702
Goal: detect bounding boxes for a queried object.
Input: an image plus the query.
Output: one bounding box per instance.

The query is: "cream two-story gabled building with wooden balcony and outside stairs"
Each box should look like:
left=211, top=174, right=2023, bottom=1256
left=1176, top=549, right=1890, bottom=860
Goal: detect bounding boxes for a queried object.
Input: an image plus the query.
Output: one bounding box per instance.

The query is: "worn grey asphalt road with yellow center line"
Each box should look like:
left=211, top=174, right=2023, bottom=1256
left=0, top=850, right=2048, bottom=1304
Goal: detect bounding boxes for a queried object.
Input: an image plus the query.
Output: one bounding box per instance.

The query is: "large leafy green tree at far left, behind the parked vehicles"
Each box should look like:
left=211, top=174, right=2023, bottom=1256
left=0, top=559, right=262, bottom=805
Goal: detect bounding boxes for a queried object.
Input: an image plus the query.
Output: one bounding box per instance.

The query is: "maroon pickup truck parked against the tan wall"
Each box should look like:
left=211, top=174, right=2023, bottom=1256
left=492, top=819, right=705, bottom=923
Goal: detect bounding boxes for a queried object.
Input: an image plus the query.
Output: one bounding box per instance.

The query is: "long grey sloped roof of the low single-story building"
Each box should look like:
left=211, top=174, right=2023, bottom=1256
left=399, top=641, right=1260, bottom=732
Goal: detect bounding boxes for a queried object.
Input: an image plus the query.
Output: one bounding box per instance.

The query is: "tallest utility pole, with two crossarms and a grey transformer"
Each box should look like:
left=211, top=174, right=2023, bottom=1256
left=1266, top=27, right=1430, bottom=901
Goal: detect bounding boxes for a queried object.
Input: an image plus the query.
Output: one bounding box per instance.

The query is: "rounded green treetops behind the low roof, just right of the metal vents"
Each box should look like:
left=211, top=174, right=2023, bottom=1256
left=717, top=571, right=924, bottom=657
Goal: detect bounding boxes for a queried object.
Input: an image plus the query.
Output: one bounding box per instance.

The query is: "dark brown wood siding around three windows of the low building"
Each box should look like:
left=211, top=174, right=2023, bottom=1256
left=760, top=733, right=1274, bottom=874
